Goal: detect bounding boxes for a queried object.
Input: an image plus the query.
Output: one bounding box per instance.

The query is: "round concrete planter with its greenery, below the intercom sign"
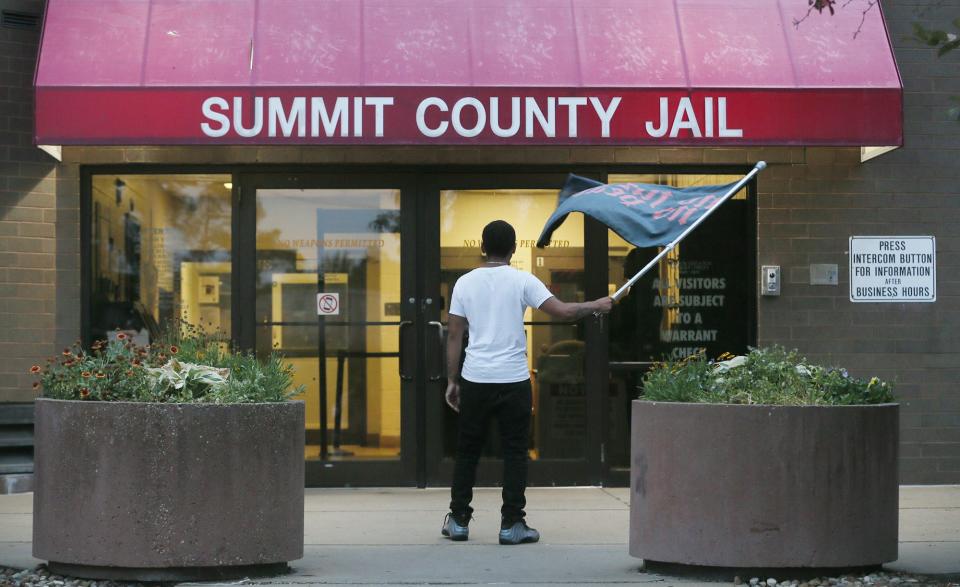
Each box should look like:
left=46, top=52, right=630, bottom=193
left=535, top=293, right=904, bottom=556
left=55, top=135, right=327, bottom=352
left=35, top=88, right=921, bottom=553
left=630, top=346, right=899, bottom=569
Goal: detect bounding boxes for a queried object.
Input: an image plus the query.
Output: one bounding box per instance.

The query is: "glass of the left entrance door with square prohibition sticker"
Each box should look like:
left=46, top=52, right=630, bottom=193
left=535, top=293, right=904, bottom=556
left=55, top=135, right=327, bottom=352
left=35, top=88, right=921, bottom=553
left=255, top=188, right=404, bottom=463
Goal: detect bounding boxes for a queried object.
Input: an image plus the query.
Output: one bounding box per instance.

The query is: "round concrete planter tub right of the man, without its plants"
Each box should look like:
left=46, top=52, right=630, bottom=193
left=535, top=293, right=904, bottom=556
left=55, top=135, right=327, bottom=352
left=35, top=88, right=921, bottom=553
left=630, top=401, right=899, bottom=568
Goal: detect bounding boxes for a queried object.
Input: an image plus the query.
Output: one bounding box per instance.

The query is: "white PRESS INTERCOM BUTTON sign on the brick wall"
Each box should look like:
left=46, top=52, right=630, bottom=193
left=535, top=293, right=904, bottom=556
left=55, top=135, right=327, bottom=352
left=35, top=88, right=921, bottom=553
left=850, top=236, right=937, bottom=302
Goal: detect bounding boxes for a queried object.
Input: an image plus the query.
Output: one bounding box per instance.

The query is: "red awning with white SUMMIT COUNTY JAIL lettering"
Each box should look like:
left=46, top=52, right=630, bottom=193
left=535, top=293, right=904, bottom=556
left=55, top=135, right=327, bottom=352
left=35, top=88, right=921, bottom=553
left=36, top=0, right=902, bottom=146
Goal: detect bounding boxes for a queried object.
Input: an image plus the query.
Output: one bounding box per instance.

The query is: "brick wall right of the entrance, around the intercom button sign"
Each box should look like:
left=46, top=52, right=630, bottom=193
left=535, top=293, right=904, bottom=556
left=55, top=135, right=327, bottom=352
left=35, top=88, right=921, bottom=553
left=758, top=0, right=960, bottom=483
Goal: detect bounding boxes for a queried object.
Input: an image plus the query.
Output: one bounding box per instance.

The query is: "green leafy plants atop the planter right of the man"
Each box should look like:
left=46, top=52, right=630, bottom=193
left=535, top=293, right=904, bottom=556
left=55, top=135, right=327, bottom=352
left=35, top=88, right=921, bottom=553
left=643, top=346, right=893, bottom=406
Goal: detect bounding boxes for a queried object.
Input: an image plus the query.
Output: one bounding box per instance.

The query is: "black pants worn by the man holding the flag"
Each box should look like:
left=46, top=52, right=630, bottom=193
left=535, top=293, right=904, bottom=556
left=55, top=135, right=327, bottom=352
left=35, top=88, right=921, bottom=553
left=450, top=379, right=533, bottom=525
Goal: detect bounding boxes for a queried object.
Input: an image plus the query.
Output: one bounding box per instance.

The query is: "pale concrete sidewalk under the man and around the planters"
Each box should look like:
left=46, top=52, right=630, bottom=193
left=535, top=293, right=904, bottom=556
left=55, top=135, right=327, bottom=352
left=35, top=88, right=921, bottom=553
left=0, top=486, right=960, bottom=585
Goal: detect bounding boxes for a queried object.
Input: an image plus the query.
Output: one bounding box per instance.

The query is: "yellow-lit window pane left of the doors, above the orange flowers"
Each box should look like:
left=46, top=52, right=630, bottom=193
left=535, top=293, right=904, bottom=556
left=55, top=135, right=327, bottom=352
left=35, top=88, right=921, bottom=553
left=91, top=175, right=231, bottom=344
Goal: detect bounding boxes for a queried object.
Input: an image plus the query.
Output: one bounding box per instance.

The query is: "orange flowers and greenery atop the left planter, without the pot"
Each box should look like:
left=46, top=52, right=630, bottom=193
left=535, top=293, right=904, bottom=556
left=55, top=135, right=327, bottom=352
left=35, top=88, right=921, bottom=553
left=30, top=325, right=303, bottom=404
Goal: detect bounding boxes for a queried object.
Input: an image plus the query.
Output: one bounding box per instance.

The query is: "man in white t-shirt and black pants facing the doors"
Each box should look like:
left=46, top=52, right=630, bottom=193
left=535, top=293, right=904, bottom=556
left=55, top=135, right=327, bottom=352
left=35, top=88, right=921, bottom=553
left=442, top=220, right=613, bottom=544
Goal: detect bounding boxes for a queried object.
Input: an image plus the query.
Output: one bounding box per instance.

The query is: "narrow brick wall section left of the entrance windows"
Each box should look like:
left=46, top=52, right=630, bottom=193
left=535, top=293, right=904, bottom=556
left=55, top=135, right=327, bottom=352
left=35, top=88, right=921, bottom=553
left=0, top=0, right=79, bottom=401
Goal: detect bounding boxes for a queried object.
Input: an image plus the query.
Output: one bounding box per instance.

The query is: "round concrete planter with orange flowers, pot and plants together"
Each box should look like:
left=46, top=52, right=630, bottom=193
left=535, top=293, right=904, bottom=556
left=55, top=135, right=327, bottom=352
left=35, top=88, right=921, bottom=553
left=31, top=323, right=305, bottom=581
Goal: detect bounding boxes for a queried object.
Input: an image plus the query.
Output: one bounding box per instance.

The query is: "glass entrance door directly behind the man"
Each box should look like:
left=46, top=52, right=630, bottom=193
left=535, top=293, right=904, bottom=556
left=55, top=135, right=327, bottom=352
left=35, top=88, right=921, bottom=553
left=424, top=174, right=604, bottom=485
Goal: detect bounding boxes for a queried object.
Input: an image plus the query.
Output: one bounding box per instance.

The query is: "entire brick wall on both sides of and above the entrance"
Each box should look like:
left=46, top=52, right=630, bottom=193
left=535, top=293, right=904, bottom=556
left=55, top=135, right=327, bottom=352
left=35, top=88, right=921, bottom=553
left=0, top=0, right=960, bottom=483
